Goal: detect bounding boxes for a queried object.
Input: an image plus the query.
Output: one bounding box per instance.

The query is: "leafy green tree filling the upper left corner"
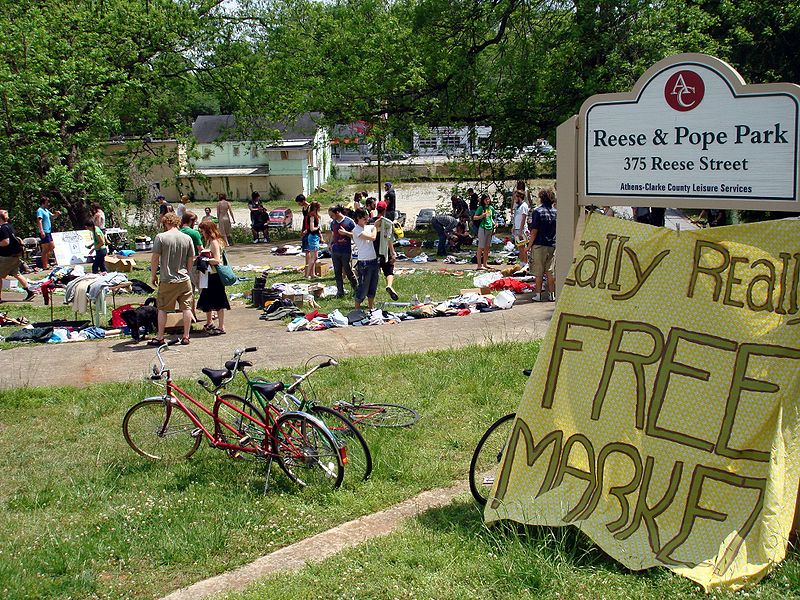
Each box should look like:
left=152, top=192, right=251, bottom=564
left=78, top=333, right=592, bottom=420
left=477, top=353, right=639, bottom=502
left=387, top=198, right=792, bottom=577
left=0, top=0, right=234, bottom=232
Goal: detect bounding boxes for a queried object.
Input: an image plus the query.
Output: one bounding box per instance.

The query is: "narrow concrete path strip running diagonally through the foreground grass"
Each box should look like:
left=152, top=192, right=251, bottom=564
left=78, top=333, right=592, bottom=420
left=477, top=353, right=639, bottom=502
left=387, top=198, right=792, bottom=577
left=163, top=483, right=467, bottom=600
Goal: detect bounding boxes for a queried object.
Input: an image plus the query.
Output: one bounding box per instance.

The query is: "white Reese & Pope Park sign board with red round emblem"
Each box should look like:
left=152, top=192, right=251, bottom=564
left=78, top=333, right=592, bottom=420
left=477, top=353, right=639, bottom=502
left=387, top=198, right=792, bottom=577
left=578, top=55, right=800, bottom=203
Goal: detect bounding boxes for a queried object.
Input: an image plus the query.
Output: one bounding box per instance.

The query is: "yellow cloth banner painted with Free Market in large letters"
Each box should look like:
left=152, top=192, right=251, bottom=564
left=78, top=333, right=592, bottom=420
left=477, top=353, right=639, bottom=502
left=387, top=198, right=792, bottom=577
left=485, top=216, right=800, bottom=590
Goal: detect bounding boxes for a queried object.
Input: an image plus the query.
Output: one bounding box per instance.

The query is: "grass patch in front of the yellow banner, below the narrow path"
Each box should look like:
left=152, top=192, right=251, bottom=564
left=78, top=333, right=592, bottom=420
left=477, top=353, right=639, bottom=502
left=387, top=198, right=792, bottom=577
left=225, top=498, right=800, bottom=600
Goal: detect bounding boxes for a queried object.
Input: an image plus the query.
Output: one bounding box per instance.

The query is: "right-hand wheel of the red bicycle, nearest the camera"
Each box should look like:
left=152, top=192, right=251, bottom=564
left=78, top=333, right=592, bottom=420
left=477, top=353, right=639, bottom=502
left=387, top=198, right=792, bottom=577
left=272, top=412, right=344, bottom=489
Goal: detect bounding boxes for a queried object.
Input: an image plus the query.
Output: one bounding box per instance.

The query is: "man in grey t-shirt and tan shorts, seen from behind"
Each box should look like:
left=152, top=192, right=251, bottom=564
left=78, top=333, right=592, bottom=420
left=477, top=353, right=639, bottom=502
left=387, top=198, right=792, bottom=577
left=148, top=212, right=194, bottom=346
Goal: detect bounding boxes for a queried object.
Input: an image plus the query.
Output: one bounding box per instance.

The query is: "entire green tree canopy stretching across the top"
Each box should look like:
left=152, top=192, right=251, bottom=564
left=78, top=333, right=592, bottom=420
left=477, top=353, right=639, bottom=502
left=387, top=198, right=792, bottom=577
left=0, top=0, right=800, bottom=230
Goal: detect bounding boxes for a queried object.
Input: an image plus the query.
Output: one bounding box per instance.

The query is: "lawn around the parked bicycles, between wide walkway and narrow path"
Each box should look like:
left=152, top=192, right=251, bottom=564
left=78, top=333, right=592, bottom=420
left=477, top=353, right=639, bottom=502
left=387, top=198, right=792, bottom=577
left=0, top=343, right=538, bottom=598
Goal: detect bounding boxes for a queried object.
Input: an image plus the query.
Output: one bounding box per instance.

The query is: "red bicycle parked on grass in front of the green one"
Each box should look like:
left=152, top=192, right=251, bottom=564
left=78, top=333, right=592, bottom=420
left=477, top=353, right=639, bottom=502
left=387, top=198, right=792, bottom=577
left=122, top=344, right=347, bottom=492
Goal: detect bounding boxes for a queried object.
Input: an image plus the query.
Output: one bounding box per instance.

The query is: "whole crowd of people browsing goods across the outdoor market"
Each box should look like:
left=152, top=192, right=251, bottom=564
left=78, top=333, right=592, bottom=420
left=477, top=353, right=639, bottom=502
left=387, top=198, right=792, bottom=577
left=0, top=181, right=724, bottom=324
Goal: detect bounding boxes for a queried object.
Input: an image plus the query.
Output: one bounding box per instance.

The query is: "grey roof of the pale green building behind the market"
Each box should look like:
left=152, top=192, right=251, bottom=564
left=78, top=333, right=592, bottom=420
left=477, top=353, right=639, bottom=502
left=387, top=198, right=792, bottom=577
left=192, top=112, right=322, bottom=144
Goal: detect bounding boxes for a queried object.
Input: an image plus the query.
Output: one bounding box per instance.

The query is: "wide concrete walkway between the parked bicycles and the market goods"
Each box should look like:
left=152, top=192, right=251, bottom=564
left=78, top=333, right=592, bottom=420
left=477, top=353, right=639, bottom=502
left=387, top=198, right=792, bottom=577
left=0, top=302, right=555, bottom=389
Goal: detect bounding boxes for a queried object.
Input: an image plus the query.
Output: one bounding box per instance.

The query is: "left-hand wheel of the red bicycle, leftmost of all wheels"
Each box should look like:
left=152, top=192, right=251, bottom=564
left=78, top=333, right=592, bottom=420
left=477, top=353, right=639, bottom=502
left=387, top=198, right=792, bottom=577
left=122, top=398, right=203, bottom=460
